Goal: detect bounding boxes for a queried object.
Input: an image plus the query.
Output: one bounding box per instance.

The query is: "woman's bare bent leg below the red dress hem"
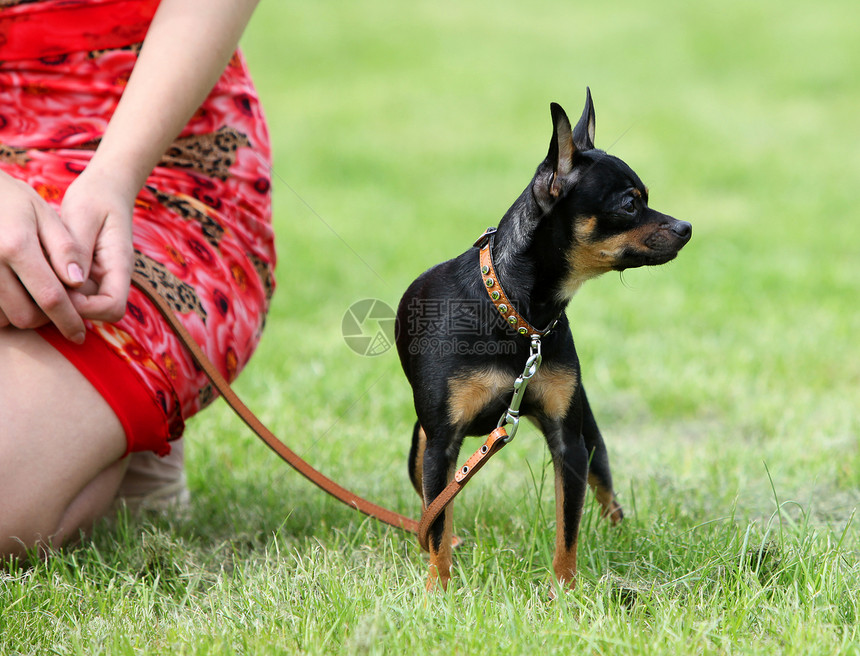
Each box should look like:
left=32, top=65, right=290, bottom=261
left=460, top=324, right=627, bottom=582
left=0, top=328, right=127, bottom=556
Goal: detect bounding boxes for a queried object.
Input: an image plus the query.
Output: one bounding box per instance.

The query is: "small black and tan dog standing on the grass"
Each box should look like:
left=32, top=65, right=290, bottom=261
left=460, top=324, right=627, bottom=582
left=397, top=90, right=692, bottom=588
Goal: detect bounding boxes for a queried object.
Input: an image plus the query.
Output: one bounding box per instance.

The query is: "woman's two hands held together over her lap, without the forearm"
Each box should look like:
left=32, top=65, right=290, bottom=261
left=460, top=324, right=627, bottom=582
left=0, top=167, right=134, bottom=343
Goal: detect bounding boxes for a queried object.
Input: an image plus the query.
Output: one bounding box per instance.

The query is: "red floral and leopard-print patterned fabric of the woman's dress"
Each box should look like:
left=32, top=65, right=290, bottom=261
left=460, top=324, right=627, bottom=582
left=0, top=0, right=275, bottom=446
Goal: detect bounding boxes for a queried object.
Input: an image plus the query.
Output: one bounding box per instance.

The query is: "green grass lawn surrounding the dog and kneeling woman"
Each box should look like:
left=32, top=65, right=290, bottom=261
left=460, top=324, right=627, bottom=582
left=0, top=0, right=860, bottom=655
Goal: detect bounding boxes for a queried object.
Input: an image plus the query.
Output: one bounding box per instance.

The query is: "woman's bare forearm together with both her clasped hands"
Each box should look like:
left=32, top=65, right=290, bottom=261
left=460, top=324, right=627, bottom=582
left=0, top=0, right=258, bottom=341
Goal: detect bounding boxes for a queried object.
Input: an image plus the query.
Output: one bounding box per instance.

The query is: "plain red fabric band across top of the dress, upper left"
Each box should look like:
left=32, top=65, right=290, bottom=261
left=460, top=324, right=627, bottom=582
left=0, top=0, right=159, bottom=61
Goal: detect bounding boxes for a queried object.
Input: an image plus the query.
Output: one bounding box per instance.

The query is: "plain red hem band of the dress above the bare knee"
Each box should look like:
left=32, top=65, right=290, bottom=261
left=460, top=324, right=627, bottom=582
left=38, top=325, right=170, bottom=457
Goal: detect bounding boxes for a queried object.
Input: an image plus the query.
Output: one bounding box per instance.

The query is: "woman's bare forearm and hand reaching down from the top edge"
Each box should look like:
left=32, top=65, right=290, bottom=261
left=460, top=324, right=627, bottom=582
left=62, top=0, right=258, bottom=321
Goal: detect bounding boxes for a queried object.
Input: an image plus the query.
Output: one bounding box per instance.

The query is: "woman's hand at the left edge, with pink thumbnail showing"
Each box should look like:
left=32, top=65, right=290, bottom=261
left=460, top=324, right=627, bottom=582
left=0, top=172, right=89, bottom=343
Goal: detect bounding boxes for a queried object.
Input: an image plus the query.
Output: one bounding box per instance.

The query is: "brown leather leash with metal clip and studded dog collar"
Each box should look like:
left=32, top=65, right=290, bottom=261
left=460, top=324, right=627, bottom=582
left=131, top=228, right=552, bottom=550
